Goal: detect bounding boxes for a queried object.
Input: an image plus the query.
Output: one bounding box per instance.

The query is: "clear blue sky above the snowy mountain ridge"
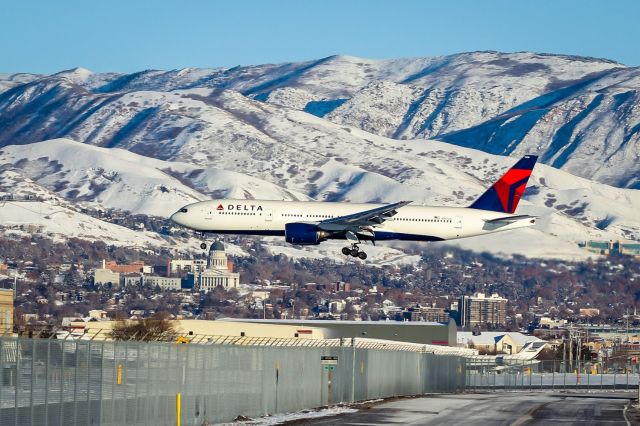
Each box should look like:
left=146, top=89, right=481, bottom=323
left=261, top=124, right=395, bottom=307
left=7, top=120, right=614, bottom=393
left=0, top=0, right=640, bottom=73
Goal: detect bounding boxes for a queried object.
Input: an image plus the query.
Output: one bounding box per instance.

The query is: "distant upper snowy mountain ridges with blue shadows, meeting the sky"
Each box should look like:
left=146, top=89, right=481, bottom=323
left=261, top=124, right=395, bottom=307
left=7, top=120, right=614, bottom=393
left=0, top=52, right=640, bottom=188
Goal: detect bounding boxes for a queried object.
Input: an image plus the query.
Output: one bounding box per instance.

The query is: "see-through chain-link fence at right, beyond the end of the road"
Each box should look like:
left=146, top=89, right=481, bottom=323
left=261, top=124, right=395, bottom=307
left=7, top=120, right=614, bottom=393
left=465, top=357, right=640, bottom=391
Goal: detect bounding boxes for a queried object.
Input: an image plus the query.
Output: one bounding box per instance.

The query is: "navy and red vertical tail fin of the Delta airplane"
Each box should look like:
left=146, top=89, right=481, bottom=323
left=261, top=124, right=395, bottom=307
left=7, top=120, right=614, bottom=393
left=469, top=155, right=538, bottom=213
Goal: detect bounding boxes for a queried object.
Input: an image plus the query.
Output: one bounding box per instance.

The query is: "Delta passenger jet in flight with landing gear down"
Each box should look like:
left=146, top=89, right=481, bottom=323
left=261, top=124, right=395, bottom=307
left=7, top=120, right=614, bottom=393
left=171, top=155, right=538, bottom=260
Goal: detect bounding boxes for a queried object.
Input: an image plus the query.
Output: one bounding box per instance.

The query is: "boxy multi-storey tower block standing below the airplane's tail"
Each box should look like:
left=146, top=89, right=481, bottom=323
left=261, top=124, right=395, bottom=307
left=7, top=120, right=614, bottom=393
left=458, top=293, right=507, bottom=327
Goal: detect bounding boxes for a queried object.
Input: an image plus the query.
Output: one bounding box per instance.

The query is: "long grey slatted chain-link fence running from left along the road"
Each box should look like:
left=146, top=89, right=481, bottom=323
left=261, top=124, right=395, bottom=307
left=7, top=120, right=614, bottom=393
left=0, top=337, right=465, bottom=426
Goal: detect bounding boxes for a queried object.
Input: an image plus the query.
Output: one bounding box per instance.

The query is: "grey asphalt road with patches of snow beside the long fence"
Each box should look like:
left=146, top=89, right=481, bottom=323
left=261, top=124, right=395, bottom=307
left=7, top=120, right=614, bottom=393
left=304, top=392, right=635, bottom=426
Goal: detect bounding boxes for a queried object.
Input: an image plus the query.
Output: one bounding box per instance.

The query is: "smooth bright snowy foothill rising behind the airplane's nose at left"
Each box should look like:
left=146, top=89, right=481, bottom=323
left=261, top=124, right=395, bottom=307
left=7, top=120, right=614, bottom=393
left=0, top=139, right=308, bottom=217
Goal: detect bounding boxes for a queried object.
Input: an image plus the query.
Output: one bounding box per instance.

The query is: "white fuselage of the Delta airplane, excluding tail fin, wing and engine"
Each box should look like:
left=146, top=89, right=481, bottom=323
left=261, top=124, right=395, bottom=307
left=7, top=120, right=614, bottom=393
left=171, top=199, right=535, bottom=241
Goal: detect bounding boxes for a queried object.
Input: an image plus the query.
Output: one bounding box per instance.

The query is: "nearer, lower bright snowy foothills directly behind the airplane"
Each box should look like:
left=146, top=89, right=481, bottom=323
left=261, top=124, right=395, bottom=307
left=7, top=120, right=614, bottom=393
left=0, top=136, right=640, bottom=262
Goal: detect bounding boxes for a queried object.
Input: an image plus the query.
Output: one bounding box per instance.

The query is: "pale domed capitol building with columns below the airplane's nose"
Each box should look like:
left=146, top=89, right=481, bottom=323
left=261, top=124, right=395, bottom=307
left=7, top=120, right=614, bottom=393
left=185, top=241, right=240, bottom=292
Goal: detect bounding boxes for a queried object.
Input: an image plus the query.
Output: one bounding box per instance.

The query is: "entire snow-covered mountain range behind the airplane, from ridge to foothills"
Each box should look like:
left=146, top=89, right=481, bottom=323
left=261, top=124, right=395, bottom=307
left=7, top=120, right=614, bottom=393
left=0, top=52, right=640, bottom=263
